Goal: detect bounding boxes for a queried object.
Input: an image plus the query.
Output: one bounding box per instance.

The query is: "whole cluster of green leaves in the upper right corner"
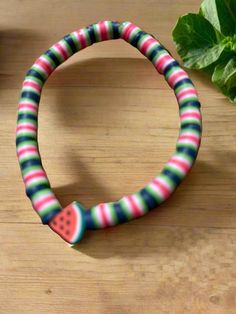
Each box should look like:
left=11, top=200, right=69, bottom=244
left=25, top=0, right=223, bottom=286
left=173, top=0, right=236, bottom=103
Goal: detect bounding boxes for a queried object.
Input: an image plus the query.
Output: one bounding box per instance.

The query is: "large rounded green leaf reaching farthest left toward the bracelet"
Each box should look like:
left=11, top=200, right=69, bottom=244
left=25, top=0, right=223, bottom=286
left=173, top=13, right=224, bottom=69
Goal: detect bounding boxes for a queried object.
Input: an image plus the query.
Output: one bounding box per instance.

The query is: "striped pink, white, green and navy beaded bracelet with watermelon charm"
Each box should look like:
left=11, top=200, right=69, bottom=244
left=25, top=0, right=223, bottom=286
left=16, top=21, right=202, bottom=244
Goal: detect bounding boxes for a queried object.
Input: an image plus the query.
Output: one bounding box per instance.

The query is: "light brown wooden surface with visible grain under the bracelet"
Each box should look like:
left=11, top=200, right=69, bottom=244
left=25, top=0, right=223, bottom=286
left=0, top=0, right=236, bottom=314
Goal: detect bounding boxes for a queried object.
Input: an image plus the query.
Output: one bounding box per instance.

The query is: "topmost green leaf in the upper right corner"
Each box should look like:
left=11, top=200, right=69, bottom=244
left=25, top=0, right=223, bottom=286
left=199, top=0, right=236, bottom=36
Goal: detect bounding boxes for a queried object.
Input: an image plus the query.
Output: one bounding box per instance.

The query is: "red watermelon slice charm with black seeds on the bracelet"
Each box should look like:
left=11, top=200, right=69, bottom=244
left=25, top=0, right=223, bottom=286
left=48, top=202, right=85, bottom=245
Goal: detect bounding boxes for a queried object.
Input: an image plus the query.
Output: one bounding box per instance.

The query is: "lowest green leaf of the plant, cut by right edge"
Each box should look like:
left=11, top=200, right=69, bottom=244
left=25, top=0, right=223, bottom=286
left=212, top=56, right=236, bottom=102
